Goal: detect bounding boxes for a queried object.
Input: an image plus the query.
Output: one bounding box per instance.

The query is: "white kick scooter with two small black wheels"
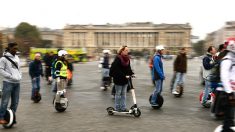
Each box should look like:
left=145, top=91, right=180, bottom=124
left=106, top=77, right=141, bottom=117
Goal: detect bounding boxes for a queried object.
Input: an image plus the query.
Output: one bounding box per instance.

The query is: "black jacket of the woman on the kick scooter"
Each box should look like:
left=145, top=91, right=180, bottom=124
left=109, top=57, right=134, bottom=85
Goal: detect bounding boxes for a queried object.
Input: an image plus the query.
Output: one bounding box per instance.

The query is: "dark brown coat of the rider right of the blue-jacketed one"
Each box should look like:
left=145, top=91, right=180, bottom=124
left=174, top=53, right=187, bottom=73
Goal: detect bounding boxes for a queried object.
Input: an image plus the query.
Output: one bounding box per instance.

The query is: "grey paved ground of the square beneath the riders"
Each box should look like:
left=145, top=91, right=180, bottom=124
left=0, top=59, right=221, bottom=132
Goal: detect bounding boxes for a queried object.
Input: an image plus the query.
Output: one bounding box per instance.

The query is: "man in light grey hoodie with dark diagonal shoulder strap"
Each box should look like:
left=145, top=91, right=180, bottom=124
left=0, top=42, right=22, bottom=124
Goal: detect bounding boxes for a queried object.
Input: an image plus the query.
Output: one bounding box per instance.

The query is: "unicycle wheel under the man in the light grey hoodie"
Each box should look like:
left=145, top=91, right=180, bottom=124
left=2, top=108, right=16, bottom=129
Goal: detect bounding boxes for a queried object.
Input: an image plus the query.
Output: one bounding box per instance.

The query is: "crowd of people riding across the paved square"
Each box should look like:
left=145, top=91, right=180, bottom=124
left=0, top=39, right=235, bottom=132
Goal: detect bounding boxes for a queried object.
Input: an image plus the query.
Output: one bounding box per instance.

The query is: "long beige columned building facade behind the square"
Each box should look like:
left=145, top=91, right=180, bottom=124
left=63, top=22, right=191, bottom=55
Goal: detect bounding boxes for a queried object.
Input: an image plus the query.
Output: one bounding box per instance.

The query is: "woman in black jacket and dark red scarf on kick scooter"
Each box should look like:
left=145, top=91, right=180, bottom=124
left=109, top=46, right=134, bottom=112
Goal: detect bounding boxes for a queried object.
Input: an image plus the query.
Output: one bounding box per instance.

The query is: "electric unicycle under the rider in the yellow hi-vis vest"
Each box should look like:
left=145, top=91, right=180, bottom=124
left=53, top=89, right=68, bottom=112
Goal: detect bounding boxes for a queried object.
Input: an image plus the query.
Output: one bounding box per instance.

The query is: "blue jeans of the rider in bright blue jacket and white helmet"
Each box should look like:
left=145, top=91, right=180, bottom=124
left=151, top=79, right=163, bottom=104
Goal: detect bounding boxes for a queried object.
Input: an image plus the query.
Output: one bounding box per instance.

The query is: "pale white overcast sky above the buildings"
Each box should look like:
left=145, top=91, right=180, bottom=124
left=0, top=0, right=235, bottom=39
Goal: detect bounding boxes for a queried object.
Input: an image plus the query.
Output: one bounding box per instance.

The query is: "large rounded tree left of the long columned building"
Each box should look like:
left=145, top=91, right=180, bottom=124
left=15, top=22, right=42, bottom=55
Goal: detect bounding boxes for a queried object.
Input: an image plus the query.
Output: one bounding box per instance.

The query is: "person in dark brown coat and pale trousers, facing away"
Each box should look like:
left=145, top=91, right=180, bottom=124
left=172, top=48, right=187, bottom=94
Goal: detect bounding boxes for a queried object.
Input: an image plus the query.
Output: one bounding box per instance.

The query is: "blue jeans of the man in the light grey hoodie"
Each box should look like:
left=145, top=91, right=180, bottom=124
left=0, top=81, right=20, bottom=119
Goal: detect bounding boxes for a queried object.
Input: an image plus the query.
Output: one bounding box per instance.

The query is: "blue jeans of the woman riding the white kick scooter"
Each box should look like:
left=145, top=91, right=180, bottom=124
left=115, top=84, right=127, bottom=111
